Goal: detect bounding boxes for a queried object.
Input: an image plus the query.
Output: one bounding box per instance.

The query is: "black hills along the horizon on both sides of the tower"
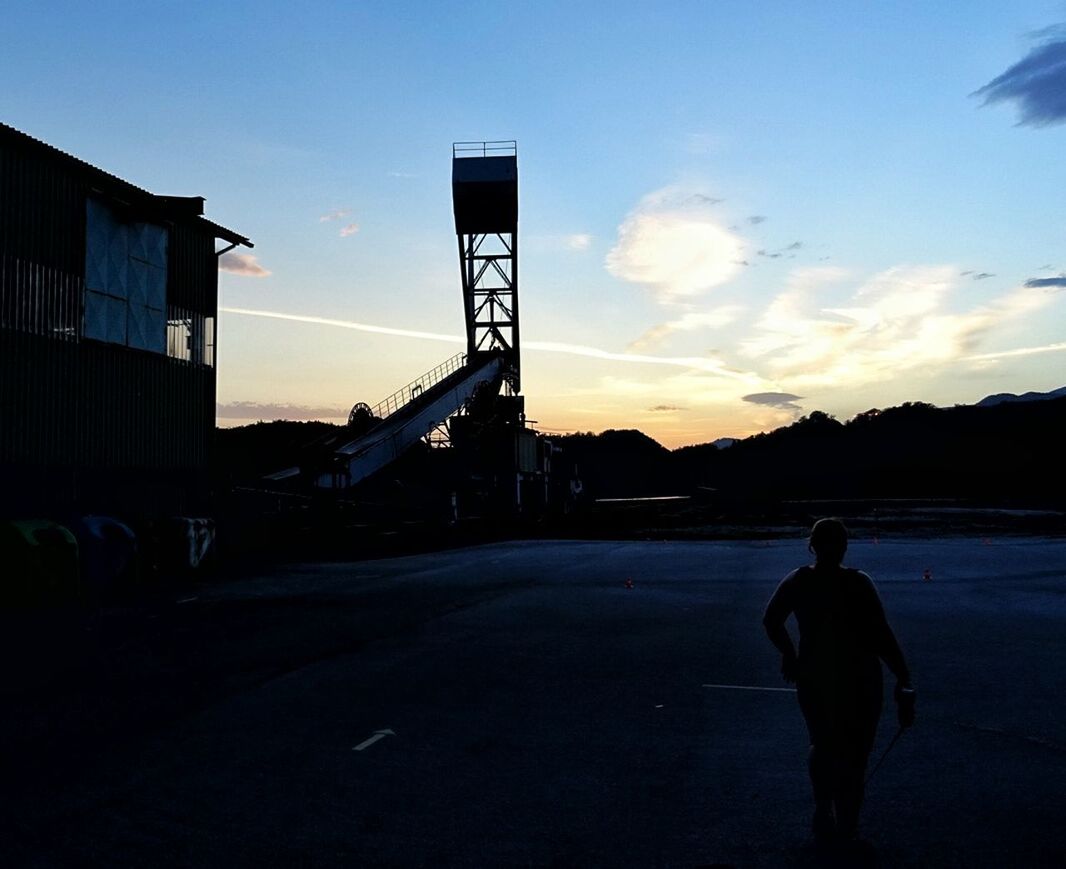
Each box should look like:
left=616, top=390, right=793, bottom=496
left=216, top=398, right=1066, bottom=504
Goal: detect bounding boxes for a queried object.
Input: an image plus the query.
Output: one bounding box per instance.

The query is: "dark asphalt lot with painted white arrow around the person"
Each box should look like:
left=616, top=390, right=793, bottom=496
left=0, top=538, right=1066, bottom=869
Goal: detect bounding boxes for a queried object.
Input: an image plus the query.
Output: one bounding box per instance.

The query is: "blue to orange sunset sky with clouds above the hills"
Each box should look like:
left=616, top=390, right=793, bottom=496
left=6, top=0, right=1066, bottom=447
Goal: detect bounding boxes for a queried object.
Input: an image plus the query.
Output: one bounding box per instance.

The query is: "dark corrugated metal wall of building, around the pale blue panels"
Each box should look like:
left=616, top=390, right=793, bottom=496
left=0, top=127, right=217, bottom=515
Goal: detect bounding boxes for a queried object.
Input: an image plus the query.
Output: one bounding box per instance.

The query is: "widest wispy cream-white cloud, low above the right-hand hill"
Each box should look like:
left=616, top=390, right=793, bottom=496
left=741, top=265, right=1052, bottom=391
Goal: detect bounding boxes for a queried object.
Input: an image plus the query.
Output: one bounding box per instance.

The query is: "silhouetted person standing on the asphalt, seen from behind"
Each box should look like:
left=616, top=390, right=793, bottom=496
left=762, top=519, right=914, bottom=842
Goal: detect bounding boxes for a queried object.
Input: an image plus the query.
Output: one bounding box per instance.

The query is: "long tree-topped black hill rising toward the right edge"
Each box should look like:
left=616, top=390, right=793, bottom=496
left=675, top=399, right=1066, bottom=501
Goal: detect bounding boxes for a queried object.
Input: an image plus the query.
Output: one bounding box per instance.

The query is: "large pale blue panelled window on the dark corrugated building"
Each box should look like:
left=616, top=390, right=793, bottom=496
left=82, top=199, right=168, bottom=353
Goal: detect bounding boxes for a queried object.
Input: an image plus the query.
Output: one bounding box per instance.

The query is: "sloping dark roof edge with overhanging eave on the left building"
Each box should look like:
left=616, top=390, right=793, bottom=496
left=0, top=123, right=254, bottom=247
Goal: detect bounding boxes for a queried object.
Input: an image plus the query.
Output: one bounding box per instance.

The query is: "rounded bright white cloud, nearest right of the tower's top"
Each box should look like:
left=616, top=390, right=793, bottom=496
left=605, top=188, right=744, bottom=304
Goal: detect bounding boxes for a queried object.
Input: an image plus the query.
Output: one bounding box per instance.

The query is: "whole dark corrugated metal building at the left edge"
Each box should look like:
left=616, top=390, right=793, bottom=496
left=0, top=124, right=252, bottom=516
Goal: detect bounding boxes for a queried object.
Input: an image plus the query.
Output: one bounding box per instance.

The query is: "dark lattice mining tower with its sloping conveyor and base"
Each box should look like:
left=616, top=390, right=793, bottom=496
left=267, top=141, right=580, bottom=515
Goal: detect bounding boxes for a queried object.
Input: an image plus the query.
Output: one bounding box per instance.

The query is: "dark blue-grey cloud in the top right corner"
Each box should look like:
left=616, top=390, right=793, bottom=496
left=970, top=25, right=1066, bottom=127
